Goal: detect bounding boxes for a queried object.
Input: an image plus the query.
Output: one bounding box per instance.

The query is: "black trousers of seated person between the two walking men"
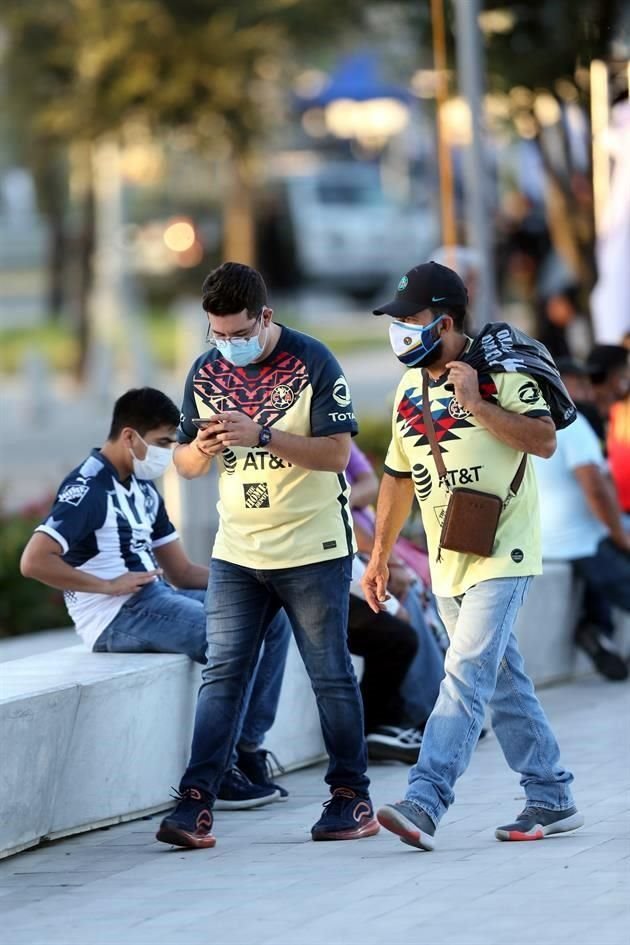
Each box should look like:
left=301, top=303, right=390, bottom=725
left=348, top=594, right=418, bottom=732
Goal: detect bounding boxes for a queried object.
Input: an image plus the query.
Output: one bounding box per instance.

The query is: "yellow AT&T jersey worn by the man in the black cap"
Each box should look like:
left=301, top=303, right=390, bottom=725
left=385, top=368, right=549, bottom=597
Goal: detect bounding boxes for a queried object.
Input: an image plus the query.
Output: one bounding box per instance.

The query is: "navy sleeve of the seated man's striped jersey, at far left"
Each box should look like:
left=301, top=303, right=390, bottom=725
left=35, top=475, right=107, bottom=555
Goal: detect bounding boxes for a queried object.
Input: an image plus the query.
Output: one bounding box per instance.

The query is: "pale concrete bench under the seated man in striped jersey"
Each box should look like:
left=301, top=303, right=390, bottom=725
left=0, top=642, right=336, bottom=856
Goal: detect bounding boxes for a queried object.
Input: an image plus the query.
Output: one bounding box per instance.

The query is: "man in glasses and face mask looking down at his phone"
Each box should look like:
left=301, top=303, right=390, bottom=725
left=157, top=263, right=379, bottom=847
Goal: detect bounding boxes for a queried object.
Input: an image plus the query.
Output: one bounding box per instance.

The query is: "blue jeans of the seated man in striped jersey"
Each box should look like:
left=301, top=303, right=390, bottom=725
left=93, top=581, right=291, bottom=752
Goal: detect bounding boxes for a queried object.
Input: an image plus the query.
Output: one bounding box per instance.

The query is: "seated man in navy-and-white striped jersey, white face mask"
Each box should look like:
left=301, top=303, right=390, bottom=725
left=21, top=387, right=291, bottom=807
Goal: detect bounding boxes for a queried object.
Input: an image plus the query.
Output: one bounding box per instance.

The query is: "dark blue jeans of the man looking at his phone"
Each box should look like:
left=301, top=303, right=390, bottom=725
left=180, top=556, right=369, bottom=797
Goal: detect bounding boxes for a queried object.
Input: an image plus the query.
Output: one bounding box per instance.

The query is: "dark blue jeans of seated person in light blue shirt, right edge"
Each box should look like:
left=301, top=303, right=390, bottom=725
left=573, top=538, right=630, bottom=633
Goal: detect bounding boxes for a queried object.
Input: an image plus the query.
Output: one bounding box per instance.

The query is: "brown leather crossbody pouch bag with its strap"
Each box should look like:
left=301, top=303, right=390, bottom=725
left=422, top=371, right=527, bottom=561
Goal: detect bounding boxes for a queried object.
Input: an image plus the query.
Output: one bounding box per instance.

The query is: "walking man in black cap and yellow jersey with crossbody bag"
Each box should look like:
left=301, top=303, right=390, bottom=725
left=362, top=262, right=584, bottom=850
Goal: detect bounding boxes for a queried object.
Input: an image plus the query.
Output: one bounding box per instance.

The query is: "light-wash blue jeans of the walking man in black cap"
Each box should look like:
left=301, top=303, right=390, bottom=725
left=407, top=577, right=573, bottom=824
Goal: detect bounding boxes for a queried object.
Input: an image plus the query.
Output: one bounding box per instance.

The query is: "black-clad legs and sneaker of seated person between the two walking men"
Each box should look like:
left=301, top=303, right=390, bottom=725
left=348, top=558, right=424, bottom=765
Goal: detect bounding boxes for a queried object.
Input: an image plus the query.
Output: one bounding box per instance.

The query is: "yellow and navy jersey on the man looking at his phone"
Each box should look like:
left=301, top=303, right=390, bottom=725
left=178, top=326, right=357, bottom=569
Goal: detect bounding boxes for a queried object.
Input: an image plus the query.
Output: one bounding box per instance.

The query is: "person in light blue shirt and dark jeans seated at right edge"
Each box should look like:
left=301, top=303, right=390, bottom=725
left=533, top=359, right=630, bottom=680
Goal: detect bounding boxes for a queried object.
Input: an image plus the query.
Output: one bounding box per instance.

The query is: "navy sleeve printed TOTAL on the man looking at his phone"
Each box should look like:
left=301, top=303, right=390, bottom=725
left=310, top=345, right=359, bottom=436
